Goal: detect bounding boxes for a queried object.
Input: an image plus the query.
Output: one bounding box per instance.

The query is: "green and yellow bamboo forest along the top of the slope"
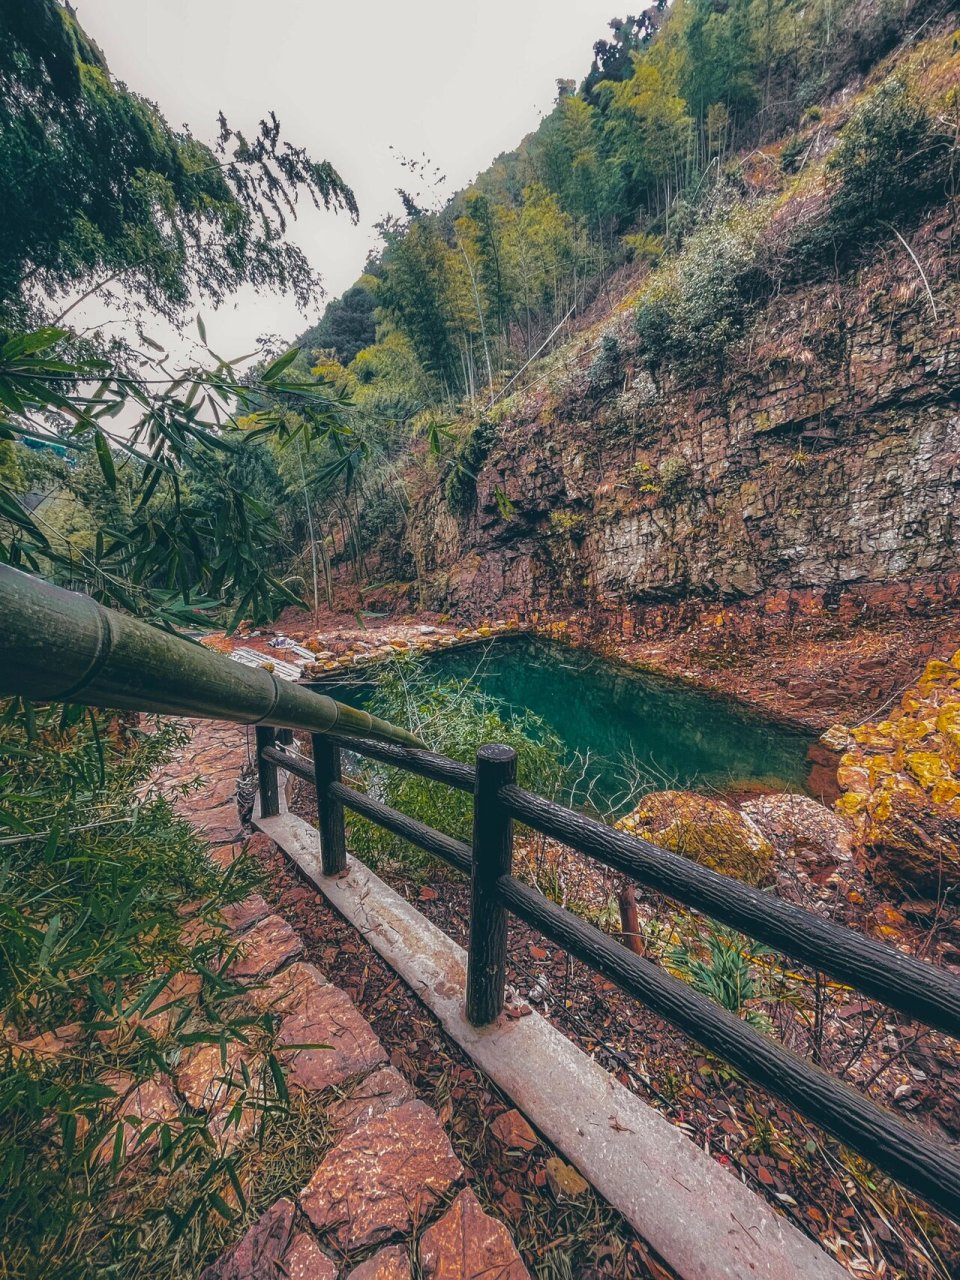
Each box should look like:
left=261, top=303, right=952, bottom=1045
left=298, top=0, right=950, bottom=399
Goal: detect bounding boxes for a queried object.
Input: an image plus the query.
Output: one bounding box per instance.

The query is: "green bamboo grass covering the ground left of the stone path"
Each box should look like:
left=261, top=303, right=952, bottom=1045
left=0, top=703, right=285, bottom=1280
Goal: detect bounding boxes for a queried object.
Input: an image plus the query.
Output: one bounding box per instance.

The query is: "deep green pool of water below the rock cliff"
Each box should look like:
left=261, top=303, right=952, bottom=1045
left=316, top=636, right=815, bottom=810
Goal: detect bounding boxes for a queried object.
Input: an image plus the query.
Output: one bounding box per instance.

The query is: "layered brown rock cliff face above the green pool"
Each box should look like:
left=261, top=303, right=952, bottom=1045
left=410, top=219, right=960, bottom=631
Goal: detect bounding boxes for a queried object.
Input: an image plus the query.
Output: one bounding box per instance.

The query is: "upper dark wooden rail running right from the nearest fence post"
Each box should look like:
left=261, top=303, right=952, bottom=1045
left=499, top=786, right=960, bottom=1037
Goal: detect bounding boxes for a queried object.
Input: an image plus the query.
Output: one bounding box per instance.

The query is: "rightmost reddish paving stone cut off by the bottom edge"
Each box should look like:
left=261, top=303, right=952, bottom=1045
left=420, top=1189, right=530, bottom=1280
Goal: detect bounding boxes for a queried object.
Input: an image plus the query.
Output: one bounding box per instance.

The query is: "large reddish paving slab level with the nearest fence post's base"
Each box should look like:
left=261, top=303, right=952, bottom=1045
left=276, top=983, right=387, bottom=1089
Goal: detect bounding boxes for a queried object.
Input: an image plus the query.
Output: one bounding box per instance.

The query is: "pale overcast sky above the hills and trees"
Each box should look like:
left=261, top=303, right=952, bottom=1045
left=73, top=0, right=622, bottom=356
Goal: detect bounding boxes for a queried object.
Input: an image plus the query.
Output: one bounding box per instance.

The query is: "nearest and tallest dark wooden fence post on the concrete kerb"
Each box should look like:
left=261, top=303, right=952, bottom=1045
left=467, top=746, right=517, bottom=1027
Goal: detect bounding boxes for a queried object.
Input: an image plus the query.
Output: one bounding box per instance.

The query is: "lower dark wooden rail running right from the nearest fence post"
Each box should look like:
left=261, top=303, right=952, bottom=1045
left=497, top=876, right=960, bottom=1219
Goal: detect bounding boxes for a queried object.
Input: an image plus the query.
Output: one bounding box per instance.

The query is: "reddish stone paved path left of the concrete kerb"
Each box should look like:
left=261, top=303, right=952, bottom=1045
left=160, top=722, right=529, bottom=1280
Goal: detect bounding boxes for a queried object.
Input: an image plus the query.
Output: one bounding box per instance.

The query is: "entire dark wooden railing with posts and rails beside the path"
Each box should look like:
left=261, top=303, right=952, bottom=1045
left=257, top=728, right=960, bottom=1221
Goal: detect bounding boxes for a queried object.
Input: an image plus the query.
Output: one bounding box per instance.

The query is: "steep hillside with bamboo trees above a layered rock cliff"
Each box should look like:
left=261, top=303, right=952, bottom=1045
left=291, top=0, right=960, bottom=629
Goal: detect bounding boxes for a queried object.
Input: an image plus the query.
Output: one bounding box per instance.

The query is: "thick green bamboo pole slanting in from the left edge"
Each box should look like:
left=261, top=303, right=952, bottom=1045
left=0, top=564, right=424, bottom=746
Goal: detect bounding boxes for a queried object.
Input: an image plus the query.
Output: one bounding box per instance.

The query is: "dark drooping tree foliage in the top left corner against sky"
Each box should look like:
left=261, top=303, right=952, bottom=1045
left=0, top=0, right=357, bottom=321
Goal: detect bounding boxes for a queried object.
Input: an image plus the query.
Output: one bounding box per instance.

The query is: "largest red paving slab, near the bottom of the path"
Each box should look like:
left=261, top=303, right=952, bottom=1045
left=300, top=1102, right=463, bottom=1253
